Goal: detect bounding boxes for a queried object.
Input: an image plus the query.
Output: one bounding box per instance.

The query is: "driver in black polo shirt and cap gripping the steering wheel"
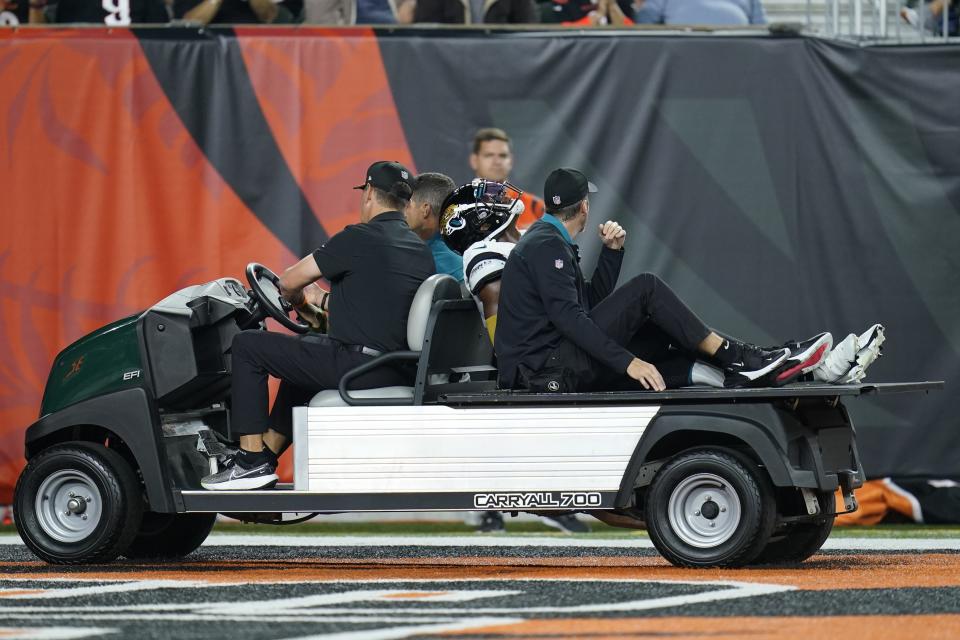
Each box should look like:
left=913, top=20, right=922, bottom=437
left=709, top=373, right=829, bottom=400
left=201, top=162, right=435, bottom=490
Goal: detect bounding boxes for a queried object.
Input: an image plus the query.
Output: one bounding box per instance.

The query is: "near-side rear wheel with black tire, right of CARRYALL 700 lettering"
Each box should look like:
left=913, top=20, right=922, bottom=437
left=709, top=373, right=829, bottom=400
left=646, top=449, right=776, bottom=567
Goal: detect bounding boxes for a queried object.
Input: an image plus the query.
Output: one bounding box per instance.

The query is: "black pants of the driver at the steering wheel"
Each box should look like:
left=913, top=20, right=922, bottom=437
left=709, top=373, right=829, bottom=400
left=231, top=330, right=413, bottom=438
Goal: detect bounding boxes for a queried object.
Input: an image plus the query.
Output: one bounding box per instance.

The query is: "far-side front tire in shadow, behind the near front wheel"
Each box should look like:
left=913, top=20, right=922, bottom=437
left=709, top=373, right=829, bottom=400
left=123, top=511, right=217, bottom=560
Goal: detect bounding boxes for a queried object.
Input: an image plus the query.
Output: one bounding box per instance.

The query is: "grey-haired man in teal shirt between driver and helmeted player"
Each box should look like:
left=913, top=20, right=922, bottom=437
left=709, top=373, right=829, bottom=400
left=404, top=173, right=463, bottom=282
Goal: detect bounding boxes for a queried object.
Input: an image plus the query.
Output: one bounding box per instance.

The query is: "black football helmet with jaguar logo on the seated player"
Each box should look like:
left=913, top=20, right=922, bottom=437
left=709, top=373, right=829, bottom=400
left=440, top=178, right=524, bottom=255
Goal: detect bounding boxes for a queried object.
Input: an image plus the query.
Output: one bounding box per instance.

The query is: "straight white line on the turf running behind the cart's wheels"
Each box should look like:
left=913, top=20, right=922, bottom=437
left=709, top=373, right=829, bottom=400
left=0, top=533, right=960, bottom=551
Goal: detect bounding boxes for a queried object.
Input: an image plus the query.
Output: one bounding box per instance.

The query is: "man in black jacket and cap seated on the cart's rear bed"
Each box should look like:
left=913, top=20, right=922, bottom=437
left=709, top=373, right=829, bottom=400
left=495, top=169, right=790, bottom=392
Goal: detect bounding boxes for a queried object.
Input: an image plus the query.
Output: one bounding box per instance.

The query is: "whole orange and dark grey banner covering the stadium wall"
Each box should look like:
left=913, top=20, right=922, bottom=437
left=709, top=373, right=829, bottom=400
left=0, top=28, right=960, bottom=504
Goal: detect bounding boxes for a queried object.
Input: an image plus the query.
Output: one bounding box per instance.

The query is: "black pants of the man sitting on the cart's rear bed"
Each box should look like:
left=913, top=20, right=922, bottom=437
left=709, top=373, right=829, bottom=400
left=556, top=273, right=710, bottom=391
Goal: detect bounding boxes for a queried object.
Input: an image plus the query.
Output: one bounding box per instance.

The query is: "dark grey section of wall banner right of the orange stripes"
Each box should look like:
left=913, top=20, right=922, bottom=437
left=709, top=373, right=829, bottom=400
left=380, top=34, right=960, bottom=476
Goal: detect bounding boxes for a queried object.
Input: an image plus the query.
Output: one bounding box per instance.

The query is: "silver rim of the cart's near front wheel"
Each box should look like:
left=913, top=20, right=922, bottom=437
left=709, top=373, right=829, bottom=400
left=34, top=469, right=103, bottom=543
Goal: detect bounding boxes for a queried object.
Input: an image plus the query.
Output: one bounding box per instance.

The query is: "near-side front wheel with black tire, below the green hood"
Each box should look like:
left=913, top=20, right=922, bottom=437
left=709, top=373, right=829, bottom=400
left=14, top=442, right=143, bottom=564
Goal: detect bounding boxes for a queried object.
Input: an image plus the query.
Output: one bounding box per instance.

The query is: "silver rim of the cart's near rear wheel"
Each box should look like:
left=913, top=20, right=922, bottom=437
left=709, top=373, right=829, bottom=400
left=667, top=473, right=741, bottom=549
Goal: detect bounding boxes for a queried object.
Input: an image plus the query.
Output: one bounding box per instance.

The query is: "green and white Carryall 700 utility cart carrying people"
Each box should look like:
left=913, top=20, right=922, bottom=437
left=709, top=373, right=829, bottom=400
left=15, top=263, right=942, bottom=567
